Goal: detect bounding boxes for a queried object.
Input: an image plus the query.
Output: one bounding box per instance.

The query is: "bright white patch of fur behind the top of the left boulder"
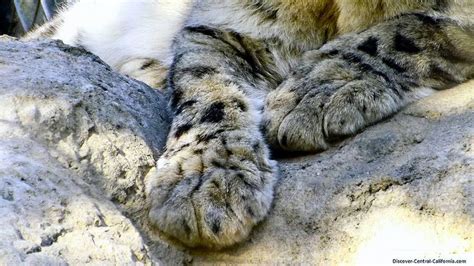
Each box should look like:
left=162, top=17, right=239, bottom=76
left=53, top=0, right=192, bottom=71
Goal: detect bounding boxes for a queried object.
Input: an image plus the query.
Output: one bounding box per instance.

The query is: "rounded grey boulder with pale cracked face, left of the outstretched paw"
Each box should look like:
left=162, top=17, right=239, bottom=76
left=0, top=37, right=177, bottom=265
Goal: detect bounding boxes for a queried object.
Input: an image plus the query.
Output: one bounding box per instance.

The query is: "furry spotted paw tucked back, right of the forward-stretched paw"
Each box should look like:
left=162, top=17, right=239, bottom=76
left=263, top=52, right=403, bottom=152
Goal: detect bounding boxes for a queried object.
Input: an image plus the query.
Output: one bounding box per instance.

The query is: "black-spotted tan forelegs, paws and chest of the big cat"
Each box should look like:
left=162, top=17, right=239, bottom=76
left=30, top=0, right=474, bottom=248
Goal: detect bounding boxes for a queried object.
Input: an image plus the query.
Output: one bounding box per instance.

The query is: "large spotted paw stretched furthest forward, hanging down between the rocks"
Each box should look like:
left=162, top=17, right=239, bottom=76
left=147, top=130, right=276, bottom=248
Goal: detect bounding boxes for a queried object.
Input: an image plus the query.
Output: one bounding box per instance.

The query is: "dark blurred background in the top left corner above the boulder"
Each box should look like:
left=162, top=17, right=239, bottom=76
left=0, top=0, right=66, bottom=36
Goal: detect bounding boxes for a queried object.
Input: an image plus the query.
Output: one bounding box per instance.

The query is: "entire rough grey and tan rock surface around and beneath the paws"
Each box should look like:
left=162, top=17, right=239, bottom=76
left=0, top=38, right=474, bottom=265
